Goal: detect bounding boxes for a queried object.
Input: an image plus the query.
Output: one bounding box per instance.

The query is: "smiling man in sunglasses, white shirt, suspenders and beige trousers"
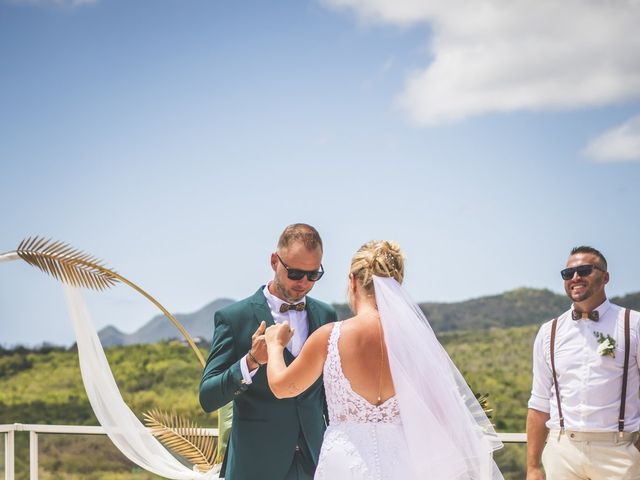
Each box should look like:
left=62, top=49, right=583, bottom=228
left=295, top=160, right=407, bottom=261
left=527, top=246, right=640, bottom=480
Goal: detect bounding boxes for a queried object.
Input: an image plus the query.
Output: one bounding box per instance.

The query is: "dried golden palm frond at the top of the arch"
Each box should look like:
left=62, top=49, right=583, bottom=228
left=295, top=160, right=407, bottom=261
left=16, top=237, right=119, bottom=290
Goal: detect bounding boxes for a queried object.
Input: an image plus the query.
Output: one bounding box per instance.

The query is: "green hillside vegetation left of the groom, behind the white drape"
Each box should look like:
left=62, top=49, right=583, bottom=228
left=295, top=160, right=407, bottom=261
left=0, top=342, right=211, bottom=480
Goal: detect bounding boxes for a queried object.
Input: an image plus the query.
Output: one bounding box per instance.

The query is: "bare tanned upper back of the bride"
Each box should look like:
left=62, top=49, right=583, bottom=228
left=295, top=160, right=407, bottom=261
left=338, top=314, right=395, bottom=405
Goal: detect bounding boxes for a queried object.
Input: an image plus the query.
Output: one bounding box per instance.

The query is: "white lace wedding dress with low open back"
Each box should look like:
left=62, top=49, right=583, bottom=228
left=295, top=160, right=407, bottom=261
left=315, top=322, right=412, bottom=480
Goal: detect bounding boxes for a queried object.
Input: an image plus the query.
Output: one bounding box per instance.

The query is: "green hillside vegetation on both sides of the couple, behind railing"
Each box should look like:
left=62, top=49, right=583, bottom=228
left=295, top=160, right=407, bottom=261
left=0, top=325, right=537, bottom=479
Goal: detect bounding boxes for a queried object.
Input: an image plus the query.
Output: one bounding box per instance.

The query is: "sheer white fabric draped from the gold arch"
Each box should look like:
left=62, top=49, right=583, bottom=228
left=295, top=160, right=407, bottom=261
left=64, top=285, right=218, bottom=480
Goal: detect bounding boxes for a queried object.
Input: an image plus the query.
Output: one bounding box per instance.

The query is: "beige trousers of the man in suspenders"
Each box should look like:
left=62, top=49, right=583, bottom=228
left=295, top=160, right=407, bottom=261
left=542, top=430, right=640, bottom=480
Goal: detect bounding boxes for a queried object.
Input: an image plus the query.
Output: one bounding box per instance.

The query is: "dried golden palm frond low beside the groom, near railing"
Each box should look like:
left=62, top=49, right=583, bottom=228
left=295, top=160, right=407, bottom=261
left=144, top=409, right=216, bottom=472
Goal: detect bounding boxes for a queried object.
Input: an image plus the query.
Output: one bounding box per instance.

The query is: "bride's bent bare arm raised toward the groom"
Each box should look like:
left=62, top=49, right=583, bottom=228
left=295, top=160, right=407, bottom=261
left=265, top=322, right=333, bottom=398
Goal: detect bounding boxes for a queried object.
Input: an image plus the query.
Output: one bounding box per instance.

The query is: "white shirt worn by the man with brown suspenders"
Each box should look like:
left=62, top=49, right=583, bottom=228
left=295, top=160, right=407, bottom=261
left=528, top=300, right=640, bottom=432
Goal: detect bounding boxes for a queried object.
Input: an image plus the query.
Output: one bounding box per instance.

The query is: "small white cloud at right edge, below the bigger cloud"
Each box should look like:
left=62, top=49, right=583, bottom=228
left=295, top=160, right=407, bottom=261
left=583, top=115, right=640, bottom=162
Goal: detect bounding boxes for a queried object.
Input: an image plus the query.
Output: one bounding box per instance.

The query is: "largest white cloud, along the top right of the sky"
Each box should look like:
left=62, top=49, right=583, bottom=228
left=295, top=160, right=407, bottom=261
left=323, top=0, right=640, bottom=125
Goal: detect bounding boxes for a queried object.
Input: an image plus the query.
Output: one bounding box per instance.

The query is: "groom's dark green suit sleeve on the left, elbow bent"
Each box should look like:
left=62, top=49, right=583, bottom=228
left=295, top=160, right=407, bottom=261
left=200, top=312, right=247, bottom=412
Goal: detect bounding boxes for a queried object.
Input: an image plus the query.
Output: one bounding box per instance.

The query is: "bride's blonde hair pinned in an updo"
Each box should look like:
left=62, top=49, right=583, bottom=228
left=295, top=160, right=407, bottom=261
left=350, top=240, right=404, bottom=293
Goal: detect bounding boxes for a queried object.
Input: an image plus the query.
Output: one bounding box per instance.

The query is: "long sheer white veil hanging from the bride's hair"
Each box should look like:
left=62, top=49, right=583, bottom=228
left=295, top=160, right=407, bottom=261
left=373, top=276, right=503, bottom=480
